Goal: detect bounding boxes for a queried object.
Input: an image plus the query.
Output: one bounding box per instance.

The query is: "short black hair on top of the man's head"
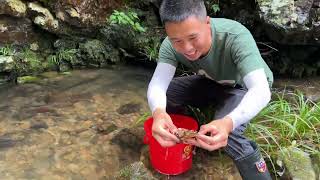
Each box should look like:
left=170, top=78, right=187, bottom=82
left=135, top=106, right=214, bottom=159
left=160, top=0, right=207, bottom=24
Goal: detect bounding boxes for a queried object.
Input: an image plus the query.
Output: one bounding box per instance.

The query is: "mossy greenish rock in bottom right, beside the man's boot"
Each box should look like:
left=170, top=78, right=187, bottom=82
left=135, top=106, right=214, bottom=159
left=279, top=147, right=316, bottom=180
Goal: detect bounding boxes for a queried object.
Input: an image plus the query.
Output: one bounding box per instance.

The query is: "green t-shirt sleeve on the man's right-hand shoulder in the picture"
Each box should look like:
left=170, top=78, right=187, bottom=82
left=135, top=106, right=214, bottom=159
left=231, top=30, right=264, bottom=78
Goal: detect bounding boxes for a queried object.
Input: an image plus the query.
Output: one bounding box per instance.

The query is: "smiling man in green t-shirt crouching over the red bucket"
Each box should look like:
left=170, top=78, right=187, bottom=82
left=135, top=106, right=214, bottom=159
left=148, top=0, right=273, bottom=180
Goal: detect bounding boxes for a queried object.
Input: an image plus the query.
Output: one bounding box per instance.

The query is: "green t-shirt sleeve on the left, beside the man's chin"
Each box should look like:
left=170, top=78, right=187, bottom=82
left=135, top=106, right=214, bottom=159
left=158, top=37, right=178, bottom=67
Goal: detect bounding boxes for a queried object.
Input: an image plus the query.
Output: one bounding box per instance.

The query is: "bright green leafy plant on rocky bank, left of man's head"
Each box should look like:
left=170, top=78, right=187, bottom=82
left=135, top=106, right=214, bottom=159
left=108, top=10, right=146, bottom=33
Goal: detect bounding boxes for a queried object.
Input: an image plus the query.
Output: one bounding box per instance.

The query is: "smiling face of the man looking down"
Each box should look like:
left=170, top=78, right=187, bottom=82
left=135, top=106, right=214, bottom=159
left=165, top=16, right=212, bottom=61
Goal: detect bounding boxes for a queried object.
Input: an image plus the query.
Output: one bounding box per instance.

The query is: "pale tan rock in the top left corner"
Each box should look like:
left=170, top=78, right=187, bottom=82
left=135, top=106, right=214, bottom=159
left=0, top=0, right=27, bottom=17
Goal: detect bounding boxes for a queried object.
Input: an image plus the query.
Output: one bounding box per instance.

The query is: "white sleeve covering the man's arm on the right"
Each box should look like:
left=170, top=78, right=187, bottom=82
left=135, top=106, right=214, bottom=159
left=227, top=69, right=271, bottom=129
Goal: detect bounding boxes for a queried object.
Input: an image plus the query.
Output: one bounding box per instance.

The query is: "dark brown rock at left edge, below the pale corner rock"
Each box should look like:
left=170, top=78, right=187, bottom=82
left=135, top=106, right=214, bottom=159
left=0, top=16, right=36, bottom=44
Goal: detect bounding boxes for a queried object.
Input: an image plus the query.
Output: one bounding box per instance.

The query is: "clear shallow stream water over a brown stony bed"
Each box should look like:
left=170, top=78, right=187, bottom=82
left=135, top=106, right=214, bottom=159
left=0, top=67, right=320, bottom=180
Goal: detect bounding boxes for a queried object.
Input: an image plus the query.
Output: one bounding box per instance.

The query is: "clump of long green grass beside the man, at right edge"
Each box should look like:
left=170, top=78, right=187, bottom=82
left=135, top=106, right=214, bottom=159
left=246, top=92, right=320, bottom=156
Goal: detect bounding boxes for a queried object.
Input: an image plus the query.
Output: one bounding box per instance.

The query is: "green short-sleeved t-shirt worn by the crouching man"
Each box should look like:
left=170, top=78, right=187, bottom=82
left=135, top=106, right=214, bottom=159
left=158, top=18, right=273, bottom=87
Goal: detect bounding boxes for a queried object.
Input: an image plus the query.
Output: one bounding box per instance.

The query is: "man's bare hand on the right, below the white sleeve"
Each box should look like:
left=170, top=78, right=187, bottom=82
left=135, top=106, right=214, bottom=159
left=187, top=117, right=233, bottom=151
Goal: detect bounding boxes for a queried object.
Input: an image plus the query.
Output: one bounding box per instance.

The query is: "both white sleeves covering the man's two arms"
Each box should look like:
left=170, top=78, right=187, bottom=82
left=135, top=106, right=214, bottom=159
left=147, top=63, right=271, bottom=129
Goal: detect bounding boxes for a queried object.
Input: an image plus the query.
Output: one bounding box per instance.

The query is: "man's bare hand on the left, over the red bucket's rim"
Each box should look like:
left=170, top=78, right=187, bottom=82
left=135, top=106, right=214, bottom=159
left=152, top=109, right=179, bottom=147
